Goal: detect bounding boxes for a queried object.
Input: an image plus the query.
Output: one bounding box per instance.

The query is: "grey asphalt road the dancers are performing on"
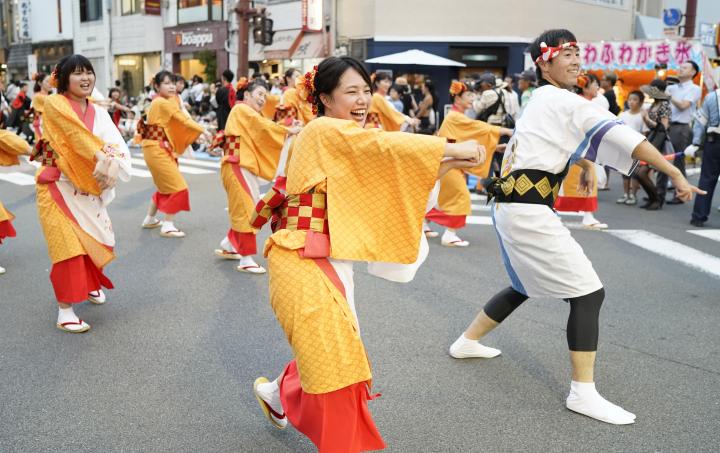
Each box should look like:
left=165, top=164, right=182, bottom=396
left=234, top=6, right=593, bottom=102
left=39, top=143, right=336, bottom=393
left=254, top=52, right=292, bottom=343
left=0, top=154, right=720, bottom=452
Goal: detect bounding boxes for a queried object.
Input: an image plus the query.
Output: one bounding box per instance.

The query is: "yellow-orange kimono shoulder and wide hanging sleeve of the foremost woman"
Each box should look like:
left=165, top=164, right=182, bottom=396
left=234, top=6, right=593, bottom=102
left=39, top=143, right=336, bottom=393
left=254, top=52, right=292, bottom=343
left=287, top=117, right=446, bottom=263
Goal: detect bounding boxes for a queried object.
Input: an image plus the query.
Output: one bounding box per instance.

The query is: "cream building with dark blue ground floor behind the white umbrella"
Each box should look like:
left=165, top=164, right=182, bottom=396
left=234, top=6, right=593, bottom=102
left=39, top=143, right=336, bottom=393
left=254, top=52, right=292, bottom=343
left=333, top=0, right=634, bottom=111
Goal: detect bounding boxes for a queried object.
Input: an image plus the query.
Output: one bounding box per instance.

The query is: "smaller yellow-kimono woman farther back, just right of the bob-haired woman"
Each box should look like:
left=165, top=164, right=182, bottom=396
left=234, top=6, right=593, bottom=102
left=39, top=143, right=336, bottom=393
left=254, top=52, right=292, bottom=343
left=138, top=71, right=204, bottom=238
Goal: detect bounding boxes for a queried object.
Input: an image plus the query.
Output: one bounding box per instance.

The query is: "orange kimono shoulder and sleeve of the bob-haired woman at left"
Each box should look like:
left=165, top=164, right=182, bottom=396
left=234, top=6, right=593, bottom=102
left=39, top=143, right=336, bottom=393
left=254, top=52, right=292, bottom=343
left=43, top=94, right=104, bottom=195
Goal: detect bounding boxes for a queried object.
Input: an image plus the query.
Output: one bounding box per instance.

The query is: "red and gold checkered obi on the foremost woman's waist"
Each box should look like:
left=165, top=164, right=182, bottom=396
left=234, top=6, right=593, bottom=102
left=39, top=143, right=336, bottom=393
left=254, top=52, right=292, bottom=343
left=251, top=187, right=330, bottom=234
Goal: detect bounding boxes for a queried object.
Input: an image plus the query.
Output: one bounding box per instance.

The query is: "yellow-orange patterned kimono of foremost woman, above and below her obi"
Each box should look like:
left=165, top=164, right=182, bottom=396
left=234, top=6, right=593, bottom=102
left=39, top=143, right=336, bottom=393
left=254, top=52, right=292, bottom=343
left=265, top=117, right=445, bottom=393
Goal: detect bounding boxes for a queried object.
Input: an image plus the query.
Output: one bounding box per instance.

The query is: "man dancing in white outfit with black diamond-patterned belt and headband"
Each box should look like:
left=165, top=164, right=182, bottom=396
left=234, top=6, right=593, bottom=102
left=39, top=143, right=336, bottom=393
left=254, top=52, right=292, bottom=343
left=450, top=30, right=702, bottom=425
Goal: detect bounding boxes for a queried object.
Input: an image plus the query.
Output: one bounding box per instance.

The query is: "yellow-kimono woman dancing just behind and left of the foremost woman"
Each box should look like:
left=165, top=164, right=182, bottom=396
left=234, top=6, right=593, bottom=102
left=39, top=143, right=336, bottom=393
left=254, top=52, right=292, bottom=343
left=213, top=78, right=301, bottom=274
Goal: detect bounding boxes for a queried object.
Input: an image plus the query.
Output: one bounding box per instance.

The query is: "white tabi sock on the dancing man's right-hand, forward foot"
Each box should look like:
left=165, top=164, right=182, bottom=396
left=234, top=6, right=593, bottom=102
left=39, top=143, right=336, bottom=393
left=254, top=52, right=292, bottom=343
left=565, top=381, right=635, bottom=425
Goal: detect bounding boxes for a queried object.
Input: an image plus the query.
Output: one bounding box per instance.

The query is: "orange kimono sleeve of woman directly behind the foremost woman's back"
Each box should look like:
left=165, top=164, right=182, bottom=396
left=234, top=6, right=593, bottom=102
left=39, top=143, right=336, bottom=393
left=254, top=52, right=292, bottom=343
left=225, top=104, right=288, bottom=181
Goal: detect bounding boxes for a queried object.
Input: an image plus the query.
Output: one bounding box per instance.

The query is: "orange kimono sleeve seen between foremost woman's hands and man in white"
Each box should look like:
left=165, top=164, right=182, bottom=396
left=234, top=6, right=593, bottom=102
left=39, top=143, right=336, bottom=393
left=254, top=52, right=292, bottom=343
left=438, top=111, right=500, bottom=178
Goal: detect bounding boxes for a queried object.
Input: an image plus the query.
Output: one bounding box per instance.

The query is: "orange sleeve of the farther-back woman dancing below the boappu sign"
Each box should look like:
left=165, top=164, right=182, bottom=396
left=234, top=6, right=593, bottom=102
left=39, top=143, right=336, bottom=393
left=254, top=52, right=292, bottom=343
left=147, top=96, right=204, bottom=154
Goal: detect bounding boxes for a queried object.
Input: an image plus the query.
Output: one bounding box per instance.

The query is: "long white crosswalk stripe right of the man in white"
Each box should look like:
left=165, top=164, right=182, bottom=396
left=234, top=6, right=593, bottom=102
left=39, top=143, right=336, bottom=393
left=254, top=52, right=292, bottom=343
left=607, top=230, right=720, bottom=277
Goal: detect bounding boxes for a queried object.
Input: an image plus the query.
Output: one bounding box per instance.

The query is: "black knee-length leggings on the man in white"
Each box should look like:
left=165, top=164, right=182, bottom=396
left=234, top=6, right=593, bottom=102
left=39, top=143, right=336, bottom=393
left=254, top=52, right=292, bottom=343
left=483, top=287, right=605, bottom=351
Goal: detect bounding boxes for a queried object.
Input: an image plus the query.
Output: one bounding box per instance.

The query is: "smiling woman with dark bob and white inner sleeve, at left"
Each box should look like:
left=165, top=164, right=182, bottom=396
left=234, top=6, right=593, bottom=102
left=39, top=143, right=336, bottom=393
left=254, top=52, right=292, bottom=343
left=33, top=55, right=130, bottom=333
